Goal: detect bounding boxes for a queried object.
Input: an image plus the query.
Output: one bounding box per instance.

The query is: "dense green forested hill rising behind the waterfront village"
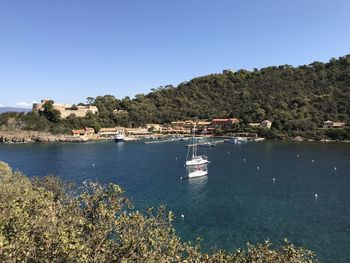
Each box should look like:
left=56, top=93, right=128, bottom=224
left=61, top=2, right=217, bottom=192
left=115, top=55, right=350, bottom=129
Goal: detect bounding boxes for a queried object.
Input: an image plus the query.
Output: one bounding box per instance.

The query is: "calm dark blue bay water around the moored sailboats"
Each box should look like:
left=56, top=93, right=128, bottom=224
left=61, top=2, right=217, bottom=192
left=0, top=142, right=350, bottom=262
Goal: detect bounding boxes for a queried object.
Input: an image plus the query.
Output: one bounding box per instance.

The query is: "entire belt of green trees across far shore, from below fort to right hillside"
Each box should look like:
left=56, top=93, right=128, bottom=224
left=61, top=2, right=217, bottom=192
left=0, top=55, right=350, bottom=140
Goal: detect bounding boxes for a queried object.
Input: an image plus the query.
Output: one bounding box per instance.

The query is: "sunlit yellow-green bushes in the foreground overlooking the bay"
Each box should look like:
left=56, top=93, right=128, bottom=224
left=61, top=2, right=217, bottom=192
left=0, top=162, right=316, bottom=263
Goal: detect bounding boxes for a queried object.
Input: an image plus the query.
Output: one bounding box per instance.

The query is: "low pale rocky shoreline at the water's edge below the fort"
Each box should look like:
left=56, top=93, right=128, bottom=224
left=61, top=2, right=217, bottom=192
left=0, top=131, right=91, bottom=144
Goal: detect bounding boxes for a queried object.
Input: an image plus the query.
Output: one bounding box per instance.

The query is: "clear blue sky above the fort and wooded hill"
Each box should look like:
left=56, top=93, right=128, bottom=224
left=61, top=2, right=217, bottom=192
left=0, top=0, right=350, bottom=106
